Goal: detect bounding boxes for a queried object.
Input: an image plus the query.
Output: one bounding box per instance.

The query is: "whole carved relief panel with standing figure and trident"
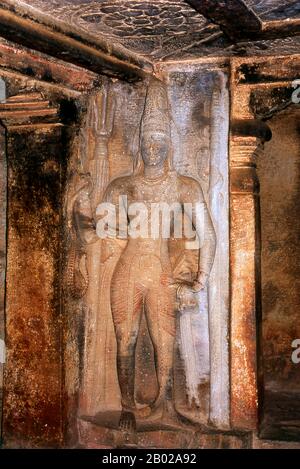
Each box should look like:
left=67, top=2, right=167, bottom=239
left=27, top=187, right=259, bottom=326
left=64, top=66, right=229, bottom=444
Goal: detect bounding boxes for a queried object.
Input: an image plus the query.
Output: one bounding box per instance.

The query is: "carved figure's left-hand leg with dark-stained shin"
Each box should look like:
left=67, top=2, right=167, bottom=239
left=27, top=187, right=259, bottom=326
left=111, top=269, right=143, bottom=412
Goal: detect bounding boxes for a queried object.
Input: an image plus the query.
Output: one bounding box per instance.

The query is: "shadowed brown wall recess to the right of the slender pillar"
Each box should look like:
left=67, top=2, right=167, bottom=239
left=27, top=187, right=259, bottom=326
left=258, top=105, right=300, bottom=440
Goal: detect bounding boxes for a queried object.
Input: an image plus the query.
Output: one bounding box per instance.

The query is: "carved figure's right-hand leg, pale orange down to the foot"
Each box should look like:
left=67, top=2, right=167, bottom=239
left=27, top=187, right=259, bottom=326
left=145, top=285, right=176, bottom=409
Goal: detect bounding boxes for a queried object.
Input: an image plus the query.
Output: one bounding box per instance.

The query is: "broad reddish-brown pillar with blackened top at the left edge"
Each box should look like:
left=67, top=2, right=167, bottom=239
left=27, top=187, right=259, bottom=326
left=0, top=93, right=64, bottom=447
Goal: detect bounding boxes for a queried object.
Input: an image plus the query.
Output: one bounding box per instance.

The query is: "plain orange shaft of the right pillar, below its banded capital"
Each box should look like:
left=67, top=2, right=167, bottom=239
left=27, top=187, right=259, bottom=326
left=231, top=194, right=257, bottom=429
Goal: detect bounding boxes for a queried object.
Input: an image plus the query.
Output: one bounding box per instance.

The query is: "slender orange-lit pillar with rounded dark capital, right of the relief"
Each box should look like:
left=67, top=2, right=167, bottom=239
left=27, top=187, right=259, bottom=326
left=230, top=121, right=271, bottom=430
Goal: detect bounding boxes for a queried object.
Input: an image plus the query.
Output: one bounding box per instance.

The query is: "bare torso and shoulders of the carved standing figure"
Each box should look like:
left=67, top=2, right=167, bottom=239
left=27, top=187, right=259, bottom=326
left=106, top=172, right=203, bottom=255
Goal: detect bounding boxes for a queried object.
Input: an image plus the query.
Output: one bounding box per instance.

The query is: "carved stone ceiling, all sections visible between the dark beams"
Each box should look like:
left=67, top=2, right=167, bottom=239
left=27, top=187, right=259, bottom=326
left=0, top=0, right=300, bottom=61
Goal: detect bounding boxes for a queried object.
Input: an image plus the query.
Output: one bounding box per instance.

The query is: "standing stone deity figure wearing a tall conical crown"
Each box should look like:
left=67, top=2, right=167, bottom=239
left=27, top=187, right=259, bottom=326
left=75, top=80, right=216, bottom=429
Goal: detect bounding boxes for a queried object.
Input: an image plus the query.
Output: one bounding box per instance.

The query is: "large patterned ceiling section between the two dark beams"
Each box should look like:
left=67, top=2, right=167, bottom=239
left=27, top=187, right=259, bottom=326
left=14, top=0, right=222, bottom=59
